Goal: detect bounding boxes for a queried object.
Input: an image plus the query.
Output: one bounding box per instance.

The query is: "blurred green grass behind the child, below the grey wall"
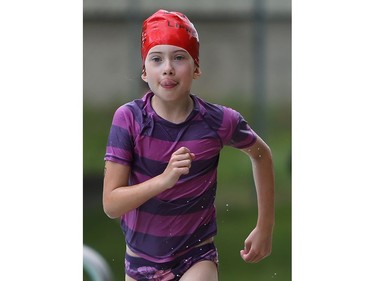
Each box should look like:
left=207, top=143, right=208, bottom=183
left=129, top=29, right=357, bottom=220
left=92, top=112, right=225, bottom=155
left=83, top=95, right=291, bottom=281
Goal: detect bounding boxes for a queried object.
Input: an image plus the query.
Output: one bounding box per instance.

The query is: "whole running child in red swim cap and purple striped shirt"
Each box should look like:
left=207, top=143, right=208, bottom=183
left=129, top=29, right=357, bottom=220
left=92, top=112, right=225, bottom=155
left=103, top=10, right=274, bottom=281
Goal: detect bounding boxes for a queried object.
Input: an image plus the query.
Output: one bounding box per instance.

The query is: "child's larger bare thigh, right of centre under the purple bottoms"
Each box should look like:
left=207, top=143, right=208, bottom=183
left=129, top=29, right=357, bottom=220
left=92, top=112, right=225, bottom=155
left=180, top=261, right=219, bottom=281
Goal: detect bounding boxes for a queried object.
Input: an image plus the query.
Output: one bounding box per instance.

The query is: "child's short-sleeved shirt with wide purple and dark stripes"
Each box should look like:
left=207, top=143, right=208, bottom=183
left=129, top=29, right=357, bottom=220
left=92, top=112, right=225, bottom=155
left=104, top=92, right=256, bottom=262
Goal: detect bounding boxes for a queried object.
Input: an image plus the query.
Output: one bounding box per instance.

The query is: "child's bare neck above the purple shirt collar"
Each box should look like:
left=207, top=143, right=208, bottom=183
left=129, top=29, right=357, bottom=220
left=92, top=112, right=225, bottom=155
left=151, top=95, right=194, bottom=124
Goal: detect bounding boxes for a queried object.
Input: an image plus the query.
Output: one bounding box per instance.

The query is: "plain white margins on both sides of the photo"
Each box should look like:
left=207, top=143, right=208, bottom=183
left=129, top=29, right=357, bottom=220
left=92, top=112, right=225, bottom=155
left=0, top=0, right=375, bottom=281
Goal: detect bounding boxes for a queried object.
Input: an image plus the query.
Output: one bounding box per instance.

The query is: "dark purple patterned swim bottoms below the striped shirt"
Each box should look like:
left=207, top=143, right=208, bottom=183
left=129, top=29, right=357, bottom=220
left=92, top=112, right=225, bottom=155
left=125, top=243, right=219, bottom=281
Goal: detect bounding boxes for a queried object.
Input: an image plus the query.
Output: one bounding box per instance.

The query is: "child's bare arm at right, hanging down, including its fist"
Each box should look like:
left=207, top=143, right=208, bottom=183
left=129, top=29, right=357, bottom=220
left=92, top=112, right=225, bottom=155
left=240, top=136, right=275, bottom=263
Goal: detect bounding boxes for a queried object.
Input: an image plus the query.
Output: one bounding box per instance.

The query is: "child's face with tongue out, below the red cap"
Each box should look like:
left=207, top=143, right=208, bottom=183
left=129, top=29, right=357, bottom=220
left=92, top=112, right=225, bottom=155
left=142, top=45, right=201, bottom=101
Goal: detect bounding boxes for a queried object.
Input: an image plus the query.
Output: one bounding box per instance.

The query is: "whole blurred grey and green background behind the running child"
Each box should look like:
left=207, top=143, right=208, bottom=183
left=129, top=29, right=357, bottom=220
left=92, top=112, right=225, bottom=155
left=83, top=0, right=291, bottom=281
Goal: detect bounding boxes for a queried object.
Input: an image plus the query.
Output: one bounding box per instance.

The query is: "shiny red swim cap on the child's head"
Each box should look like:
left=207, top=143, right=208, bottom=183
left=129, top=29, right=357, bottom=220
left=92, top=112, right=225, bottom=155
left=141, top=10, right=199, bottom=66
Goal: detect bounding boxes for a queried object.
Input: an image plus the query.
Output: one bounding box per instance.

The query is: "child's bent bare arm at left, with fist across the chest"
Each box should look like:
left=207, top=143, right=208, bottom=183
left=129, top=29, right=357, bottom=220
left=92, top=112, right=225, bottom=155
left=103, top=147, right=195, bottom=218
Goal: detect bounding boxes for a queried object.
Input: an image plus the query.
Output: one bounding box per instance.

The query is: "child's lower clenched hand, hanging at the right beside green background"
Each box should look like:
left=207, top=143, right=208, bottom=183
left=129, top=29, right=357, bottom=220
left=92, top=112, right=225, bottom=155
left=240, top=224, right=272, bottom=263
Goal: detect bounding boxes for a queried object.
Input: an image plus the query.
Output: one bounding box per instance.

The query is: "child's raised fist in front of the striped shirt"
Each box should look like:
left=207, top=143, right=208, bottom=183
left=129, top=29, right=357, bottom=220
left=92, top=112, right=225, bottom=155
left=162, top=147, right=195, bottom=188
